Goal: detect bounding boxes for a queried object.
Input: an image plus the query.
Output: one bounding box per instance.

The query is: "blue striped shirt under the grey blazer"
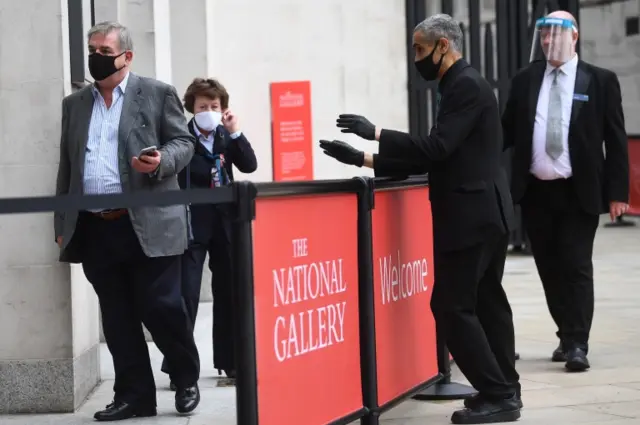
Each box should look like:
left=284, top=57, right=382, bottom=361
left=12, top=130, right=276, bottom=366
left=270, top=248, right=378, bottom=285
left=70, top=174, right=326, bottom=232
left=83, top=73, right=129, bottom=195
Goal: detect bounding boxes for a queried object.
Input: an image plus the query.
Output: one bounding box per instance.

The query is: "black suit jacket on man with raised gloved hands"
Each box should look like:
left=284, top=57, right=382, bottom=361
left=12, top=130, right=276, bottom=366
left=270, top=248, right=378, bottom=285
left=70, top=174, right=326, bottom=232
left=374, top=59, right=514, bottom=251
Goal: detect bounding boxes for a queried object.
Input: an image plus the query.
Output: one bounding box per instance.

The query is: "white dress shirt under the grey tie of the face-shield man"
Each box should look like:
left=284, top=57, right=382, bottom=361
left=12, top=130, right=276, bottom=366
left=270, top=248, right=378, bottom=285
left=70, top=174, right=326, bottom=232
left=530, top=54, right=578, bottom=180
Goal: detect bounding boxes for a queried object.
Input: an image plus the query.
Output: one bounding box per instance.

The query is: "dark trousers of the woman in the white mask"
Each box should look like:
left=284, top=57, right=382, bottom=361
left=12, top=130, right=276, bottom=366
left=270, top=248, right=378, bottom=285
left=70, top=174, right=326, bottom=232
left=162, top=215, right=235, bottom=372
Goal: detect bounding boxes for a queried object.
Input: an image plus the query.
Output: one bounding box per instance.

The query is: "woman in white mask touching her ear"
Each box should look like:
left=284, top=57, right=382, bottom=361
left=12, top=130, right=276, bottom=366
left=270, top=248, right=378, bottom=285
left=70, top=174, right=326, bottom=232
left=162, top=78, right=257, bottom=389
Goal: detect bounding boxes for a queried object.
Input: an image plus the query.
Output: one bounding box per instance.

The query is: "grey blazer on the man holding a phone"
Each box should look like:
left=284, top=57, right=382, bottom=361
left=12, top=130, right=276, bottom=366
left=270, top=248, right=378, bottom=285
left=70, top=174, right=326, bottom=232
left=54, top=73, right=194, bottom=263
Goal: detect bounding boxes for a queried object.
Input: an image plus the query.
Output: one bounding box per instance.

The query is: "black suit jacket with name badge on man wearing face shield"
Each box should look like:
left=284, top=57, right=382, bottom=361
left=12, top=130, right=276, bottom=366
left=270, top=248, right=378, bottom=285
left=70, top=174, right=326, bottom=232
left=502, top=61, right=629, bottom=214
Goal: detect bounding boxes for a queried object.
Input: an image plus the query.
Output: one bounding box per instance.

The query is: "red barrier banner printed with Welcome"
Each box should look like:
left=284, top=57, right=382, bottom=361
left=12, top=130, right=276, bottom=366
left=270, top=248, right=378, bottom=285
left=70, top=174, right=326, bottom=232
left=372, top=187, right=438, bottom=406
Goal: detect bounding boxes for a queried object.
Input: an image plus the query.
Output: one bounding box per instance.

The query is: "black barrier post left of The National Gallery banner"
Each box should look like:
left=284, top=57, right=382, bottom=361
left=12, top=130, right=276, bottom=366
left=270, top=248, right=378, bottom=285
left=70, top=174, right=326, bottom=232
left=233, top=182, right=258, bottom=425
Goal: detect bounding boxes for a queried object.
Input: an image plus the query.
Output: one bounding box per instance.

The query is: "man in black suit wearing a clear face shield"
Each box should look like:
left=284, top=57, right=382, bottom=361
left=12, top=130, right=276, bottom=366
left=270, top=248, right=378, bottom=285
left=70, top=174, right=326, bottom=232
left=502, top=11, right=629, bottom=371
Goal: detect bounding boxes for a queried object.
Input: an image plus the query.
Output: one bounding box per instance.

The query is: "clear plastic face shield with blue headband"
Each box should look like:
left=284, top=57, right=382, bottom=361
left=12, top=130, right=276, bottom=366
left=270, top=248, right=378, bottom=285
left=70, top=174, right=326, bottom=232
left=529, top=17, right=578, bottom=64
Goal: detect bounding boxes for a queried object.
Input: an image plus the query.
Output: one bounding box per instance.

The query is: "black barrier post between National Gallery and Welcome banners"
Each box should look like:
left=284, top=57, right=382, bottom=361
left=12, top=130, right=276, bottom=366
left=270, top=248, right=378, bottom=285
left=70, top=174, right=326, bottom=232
left=357, top=177, right=380, bottom=425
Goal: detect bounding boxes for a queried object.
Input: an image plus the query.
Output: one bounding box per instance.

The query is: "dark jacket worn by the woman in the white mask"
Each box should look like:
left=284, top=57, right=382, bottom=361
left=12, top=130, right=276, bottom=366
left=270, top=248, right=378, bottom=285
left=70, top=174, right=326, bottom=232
left=178, top=119, right=258, bottom=243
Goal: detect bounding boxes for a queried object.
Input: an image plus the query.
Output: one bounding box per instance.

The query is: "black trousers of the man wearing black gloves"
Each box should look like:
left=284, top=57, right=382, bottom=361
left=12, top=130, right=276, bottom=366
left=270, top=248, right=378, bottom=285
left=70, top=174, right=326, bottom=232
left=431, top=229, right=520, bottom=399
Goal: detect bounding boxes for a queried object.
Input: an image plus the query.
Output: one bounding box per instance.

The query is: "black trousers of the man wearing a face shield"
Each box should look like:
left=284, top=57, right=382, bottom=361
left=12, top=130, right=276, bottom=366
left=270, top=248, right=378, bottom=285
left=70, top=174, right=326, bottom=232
left=522, top=178, right=599, bottom=351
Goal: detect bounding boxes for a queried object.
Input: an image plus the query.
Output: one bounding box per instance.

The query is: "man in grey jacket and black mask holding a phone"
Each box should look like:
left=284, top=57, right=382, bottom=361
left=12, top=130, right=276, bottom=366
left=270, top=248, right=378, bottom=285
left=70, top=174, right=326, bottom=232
left=54, top=22, right=200, bottom=421
